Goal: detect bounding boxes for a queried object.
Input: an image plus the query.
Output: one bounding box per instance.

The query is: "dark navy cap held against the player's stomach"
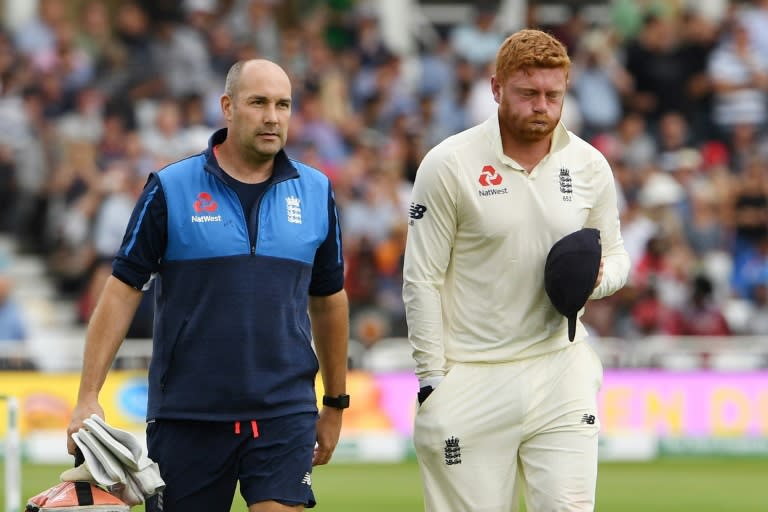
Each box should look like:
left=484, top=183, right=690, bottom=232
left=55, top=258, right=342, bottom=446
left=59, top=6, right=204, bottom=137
left=544, top=228, right=603, bottom=341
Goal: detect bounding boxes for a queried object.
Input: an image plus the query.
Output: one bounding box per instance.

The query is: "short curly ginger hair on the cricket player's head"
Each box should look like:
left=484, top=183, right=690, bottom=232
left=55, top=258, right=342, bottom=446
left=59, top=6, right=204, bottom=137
left=496, top=29, right=571, bottom=81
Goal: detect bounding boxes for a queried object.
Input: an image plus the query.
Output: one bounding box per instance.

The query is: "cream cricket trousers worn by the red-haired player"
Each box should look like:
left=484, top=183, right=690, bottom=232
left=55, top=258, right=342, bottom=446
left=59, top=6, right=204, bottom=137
left=414, top=342, right=603, bottom=512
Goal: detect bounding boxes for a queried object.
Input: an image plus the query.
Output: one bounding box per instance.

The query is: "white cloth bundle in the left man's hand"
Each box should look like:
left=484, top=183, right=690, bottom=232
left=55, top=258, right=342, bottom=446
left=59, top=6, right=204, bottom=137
left=61, top=414, right=165, bottom=506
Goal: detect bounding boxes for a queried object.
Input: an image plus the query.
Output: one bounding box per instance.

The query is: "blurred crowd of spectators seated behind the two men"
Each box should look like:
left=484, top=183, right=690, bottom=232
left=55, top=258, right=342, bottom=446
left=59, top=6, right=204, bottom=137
left=0, top=0, right=768, bottom=356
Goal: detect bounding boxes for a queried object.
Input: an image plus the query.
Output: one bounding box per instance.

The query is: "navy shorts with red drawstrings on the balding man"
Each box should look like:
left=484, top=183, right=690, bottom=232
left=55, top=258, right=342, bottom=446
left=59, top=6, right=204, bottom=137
left=146, top=413, right=317, bottom=512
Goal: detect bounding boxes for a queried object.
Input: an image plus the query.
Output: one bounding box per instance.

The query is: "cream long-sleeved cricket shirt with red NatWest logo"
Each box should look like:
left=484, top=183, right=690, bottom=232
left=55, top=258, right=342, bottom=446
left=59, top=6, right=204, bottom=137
left=403, top=114, right=630, bottom=379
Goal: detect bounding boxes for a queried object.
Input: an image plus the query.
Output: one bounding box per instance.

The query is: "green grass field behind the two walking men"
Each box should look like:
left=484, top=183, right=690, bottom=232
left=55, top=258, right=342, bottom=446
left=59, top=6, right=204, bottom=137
left=0, top=458, right=768, bottom=512
